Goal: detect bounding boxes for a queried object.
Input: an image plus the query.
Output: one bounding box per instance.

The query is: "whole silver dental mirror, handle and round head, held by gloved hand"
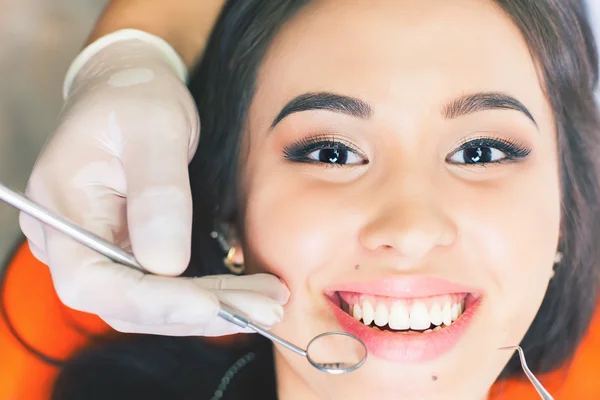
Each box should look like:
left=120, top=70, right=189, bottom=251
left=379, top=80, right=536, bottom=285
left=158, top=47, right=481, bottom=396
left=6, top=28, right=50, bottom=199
left=0, top=183, right=367, bottom=374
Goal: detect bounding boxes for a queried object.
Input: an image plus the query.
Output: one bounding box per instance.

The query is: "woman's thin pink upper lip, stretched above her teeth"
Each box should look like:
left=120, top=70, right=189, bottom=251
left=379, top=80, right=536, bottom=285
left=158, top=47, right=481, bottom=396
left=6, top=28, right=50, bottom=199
left=325, top=275, right=482, bottom=298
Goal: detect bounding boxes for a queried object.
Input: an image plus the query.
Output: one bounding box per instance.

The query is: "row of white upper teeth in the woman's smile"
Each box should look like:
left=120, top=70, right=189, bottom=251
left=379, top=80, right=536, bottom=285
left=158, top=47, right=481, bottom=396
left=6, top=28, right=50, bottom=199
left=342, top=294, right=464, bottom=330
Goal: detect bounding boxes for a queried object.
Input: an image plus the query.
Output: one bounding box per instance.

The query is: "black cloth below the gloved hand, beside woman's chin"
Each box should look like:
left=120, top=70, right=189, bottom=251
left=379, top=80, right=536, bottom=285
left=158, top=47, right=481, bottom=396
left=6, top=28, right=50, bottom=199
left=52, top=335, right=276, bottom=400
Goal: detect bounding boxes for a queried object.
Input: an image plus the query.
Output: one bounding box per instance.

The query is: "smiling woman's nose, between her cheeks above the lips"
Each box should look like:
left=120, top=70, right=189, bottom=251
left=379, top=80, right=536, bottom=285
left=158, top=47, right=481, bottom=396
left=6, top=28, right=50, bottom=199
left=359, top=196, right=456, bottom=259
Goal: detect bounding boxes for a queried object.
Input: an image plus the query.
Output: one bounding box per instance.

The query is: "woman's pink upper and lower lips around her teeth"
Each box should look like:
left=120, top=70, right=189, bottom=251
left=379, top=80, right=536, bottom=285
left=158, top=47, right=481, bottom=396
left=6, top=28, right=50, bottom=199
left=326, top=277, right=481, bottom=363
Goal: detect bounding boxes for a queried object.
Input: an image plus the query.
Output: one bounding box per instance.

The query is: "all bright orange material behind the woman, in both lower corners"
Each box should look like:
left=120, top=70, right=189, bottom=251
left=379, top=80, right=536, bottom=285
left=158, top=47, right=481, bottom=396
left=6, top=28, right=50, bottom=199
left=0, top=244, right=600, bottom=400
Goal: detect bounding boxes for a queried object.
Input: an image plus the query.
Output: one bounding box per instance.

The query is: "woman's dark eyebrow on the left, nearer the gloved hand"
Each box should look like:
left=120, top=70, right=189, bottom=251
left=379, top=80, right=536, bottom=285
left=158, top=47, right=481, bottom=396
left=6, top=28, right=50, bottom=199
left=271, top=92, right=373, bottom=129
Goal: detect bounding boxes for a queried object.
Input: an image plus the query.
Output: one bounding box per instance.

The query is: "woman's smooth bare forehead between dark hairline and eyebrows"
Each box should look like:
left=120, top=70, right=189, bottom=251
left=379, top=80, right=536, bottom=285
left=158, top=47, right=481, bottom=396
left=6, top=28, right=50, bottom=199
left=250, top=0, right=549, bottom=130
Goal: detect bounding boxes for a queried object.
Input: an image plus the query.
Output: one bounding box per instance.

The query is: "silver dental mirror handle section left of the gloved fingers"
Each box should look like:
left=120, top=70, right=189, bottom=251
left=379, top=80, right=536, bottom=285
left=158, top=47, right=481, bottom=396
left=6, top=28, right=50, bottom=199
left=0, top=183, right=144, bottom=271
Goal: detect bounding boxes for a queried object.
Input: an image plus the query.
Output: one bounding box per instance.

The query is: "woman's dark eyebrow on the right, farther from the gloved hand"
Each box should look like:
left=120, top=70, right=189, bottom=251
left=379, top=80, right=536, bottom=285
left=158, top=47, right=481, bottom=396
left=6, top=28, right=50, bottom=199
left=442, top=92, right=537, bottom=127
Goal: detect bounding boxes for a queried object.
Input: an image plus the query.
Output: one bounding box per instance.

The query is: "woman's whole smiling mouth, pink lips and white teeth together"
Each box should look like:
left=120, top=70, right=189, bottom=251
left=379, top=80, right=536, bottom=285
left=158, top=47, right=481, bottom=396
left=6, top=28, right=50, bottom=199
left=325, top=280, right=482, bottom=363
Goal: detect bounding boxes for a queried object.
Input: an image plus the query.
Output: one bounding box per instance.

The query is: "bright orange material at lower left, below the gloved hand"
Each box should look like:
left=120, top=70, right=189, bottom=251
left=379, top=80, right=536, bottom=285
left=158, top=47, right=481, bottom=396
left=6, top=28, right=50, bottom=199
left=0, top=244, right=110, bottom=400
